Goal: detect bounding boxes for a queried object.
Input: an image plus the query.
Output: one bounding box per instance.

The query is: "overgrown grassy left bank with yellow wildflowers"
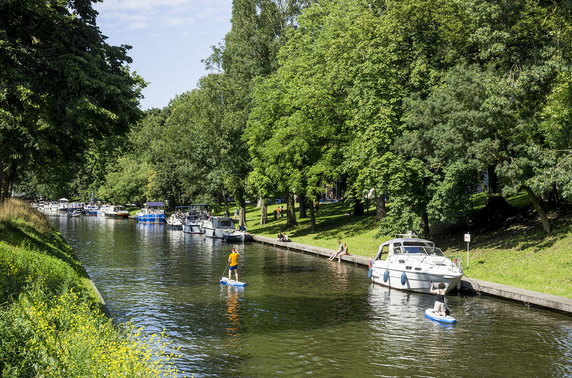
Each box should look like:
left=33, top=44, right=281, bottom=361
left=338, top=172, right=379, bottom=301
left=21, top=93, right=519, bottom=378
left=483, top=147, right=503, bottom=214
left=0, top=201, right=177, bottom=377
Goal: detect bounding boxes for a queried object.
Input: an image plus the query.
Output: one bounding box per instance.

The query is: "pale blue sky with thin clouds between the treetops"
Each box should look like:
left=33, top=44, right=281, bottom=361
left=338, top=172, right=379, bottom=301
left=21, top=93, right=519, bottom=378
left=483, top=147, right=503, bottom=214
left=93, top=0, right=232, bottom=110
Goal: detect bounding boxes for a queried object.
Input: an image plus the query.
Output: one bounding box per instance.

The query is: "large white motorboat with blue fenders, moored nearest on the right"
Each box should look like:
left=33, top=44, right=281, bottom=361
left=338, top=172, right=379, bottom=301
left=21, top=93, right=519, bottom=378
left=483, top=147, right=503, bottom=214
left=371, top=234, right=463, bottom=293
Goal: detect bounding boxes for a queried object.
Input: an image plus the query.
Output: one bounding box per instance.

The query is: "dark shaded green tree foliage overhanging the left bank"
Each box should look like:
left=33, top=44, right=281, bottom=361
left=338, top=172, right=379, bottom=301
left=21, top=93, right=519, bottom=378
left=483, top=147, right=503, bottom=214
left=0, top=0, right=143, bottom=199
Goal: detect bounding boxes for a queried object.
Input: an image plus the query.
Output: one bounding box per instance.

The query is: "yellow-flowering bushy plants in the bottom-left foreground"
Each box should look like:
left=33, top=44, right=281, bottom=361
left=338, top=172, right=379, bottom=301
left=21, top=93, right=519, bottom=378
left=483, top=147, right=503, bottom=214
left=0, top=291, right=176, bottom=377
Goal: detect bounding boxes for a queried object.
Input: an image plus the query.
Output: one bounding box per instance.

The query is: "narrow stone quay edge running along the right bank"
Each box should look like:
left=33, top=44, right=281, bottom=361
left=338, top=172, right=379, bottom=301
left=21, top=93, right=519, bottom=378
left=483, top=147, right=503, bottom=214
left=253, top=235, right=572, bottom=314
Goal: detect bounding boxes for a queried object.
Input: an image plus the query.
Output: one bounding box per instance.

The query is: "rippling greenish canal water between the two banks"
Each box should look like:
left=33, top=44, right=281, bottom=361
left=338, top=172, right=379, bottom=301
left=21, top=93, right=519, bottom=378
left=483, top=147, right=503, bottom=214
left=51, top=217, right=572, bottom=377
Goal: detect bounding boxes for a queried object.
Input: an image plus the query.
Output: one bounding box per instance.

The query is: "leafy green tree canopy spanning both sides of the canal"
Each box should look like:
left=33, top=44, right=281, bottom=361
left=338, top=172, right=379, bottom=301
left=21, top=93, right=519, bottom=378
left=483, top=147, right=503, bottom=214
left=15, top=0, right=572, bottom=235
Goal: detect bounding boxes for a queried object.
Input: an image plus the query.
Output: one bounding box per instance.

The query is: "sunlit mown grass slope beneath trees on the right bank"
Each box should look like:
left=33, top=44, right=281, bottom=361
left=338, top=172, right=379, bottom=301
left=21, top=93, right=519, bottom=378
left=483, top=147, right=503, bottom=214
left=242, top=201, right=572, bottom=298
